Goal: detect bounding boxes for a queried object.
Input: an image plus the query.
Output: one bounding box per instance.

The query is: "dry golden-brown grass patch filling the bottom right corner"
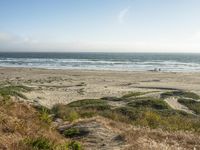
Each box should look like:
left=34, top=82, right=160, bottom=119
left=123, top=128, right=200, bottom=150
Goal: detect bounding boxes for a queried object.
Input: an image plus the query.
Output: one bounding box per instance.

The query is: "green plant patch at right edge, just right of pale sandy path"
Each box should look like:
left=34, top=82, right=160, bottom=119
left=178, top=99, right=200, bottom=115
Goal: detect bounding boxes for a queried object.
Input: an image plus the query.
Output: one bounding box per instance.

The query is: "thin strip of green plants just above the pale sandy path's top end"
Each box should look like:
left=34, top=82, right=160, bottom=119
left=161, top=91, right=200, bottom=99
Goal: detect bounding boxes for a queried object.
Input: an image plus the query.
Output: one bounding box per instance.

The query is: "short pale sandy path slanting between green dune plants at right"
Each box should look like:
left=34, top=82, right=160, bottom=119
left=165, top=97, right=194, bottom=114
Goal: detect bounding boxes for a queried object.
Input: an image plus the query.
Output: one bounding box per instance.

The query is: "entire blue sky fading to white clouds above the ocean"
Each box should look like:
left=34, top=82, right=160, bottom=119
left=0, top=0, right=200, bottom=53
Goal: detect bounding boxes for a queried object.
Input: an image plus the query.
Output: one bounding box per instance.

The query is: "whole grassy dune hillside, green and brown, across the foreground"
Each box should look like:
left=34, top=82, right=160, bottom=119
left=0, top=85, right=200, bottom=150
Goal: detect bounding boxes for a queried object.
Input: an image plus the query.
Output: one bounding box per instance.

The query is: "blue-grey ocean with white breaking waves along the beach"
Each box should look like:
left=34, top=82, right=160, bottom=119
left=0, top=52, right=200, bottom=72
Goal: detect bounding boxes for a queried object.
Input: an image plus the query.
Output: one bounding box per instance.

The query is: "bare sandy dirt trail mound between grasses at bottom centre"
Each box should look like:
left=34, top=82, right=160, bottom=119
left=58, top=117, right=126, bottom=150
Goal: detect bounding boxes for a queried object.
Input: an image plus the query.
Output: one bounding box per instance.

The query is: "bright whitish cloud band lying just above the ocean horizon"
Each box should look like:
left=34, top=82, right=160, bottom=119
left=0, top=32, right=200, bottom=52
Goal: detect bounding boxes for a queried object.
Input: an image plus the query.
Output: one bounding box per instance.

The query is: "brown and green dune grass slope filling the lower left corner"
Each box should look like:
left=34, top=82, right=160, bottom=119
left=0, top=86, right=83, bottom=150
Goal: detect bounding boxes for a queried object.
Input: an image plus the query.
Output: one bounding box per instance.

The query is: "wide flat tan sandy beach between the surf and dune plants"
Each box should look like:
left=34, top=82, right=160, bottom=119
left=0, top=67, right=200, bottom=108
